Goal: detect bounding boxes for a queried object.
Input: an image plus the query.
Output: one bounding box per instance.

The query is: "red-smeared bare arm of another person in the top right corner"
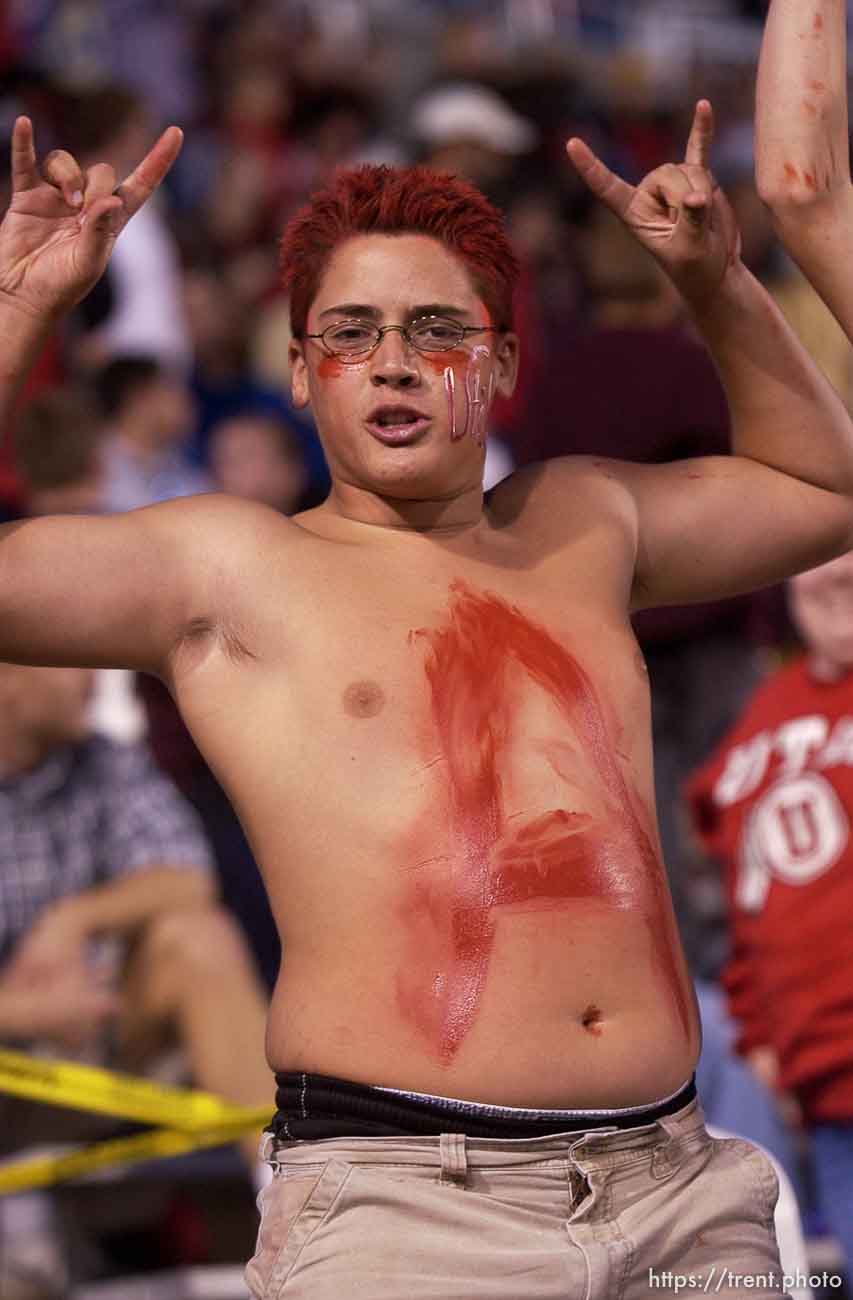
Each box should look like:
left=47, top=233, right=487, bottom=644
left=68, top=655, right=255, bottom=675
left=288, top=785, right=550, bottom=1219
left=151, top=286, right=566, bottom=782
left=755, top=0, right=853, bottom=339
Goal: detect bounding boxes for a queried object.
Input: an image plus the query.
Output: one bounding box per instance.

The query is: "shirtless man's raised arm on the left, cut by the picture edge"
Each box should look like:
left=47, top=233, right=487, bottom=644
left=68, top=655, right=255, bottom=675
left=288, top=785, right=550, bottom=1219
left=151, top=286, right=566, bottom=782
left=0, top=117, right=219, bottom=672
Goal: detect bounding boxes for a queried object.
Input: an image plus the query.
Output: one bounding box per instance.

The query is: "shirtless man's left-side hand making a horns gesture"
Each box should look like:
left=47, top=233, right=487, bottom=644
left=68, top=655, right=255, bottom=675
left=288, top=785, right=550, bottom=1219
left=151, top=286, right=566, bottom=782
left=0, top=117, right=183, bottom=319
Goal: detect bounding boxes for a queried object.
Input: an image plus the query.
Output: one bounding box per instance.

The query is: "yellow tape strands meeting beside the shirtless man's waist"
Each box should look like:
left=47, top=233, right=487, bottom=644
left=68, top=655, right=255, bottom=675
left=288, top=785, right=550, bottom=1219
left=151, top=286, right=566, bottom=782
left=0, top=1049, right=270, bottom=1196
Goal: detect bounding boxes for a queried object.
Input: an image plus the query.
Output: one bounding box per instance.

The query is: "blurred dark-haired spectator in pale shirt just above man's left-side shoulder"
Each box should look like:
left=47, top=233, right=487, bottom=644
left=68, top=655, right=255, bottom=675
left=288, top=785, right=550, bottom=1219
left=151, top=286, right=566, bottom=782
left=95, top=356, right=213, bottom=511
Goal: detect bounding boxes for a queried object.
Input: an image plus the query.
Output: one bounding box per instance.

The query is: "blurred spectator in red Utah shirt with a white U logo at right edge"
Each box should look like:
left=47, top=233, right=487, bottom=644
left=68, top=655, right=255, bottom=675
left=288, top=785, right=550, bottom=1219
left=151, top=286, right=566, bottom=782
left=689, top=555, right=853, bottom=1270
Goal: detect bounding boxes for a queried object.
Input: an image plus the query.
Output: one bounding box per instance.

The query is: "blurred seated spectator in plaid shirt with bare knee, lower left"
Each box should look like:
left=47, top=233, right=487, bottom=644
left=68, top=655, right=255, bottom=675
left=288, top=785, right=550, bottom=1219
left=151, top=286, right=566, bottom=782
left=0, top=660, right=269, bottom=1190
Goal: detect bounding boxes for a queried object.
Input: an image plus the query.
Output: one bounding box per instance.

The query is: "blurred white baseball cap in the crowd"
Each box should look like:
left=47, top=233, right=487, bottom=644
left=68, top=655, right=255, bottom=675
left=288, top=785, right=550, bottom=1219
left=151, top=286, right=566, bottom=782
left=410, top=82, right=538, bottom=153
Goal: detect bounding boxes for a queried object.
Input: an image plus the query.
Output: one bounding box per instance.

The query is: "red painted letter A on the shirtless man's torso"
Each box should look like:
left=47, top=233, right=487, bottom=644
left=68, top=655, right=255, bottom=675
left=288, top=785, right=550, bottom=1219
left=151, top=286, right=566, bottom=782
left=397, top=582, right=690, bottom=1065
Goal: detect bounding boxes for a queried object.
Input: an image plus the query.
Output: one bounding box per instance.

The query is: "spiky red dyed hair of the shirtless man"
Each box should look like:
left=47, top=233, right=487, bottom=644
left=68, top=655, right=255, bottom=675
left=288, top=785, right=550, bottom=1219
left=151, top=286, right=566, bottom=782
left=281, top=165, right=519, bottom=338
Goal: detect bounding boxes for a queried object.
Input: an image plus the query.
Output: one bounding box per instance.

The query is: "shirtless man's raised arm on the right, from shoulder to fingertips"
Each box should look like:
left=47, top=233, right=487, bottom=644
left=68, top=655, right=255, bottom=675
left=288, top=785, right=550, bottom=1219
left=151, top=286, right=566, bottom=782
left=568, top=101, right=853, bottom=607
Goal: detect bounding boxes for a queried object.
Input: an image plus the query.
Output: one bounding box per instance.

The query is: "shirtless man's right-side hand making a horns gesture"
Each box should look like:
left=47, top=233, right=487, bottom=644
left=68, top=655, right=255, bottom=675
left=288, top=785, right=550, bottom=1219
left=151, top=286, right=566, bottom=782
left=566, top=99, right=740, bottom=302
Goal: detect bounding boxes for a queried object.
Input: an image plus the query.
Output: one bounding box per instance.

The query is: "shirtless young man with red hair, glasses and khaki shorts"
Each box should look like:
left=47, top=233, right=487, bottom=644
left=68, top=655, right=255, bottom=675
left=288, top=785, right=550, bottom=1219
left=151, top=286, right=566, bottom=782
left=0, top=94, right=853, bottom=1300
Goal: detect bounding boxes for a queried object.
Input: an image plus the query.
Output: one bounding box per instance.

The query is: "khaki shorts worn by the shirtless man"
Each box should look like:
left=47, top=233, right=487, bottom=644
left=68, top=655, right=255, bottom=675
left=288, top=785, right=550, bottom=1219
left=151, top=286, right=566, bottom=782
left=246, top=1101, right=785, bottom=1300
